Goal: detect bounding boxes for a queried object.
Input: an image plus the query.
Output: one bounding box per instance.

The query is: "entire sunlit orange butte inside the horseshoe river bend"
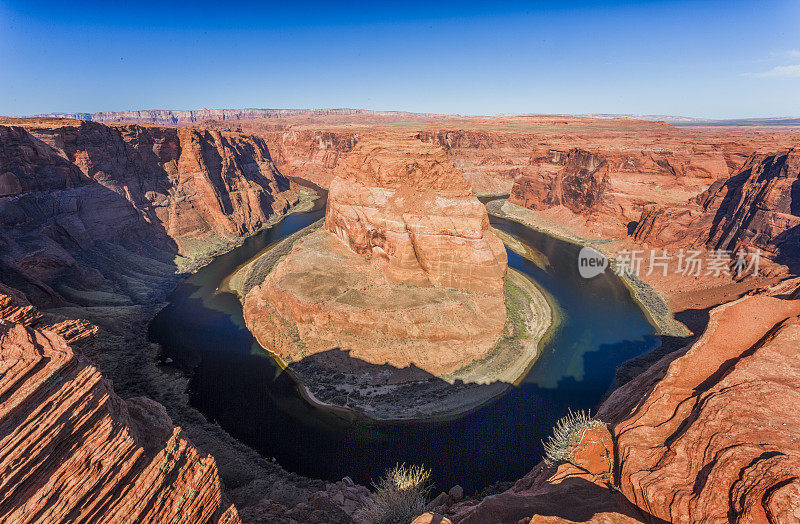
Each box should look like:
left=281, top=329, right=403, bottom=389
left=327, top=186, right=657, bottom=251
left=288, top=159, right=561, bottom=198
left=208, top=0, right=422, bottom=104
left=244, top=140, right=507, bottom=378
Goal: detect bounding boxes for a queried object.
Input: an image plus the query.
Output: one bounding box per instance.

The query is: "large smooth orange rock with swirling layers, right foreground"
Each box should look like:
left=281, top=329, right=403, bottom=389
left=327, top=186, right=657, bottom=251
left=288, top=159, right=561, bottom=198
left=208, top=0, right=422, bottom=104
left=598, top=281, right=800, bottom=523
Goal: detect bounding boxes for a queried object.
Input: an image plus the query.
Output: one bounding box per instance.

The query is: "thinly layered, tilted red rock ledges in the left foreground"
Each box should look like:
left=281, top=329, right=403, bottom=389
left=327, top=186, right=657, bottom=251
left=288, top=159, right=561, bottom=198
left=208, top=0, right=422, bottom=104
left=0, top=288, right=239, bottom=523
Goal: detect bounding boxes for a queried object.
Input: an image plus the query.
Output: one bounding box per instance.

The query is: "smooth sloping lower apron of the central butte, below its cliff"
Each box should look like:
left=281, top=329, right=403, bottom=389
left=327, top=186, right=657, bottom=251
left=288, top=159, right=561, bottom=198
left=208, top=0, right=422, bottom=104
left=244, top=231, right=506, bottom=376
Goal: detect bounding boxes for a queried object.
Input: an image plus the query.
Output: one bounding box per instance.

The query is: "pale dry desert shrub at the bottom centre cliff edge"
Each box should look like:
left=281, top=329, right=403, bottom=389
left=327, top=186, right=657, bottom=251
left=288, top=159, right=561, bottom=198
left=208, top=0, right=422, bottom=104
left=362, top=464, right=431, bottom=524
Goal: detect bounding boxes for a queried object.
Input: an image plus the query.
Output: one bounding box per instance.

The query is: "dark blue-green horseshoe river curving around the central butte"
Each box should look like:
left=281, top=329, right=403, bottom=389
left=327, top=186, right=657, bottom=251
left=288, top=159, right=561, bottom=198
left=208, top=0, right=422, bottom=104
left=150, top=199, right=659, bottom=493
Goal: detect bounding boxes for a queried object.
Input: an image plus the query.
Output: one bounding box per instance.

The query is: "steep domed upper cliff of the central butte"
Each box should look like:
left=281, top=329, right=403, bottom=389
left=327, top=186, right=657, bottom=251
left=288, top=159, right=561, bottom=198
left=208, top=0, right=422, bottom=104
left=325, top=140, right=508, bottom=295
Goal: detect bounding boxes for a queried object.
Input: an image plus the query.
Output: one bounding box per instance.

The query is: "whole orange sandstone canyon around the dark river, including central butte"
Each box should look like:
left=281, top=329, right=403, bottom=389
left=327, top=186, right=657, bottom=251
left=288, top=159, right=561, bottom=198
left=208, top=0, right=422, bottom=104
left=0, top=110, right=800, bottom=522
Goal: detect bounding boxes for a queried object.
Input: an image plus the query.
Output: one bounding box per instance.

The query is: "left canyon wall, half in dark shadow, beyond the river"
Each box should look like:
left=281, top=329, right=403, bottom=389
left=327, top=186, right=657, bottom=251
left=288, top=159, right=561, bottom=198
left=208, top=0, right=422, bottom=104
left=0, top=121, right=298, bottom=305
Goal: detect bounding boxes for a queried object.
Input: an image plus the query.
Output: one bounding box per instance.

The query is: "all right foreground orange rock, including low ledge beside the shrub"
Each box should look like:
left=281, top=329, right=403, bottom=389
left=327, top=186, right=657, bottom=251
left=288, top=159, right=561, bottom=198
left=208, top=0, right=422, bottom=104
left=438, top=279, right=800, bottom=523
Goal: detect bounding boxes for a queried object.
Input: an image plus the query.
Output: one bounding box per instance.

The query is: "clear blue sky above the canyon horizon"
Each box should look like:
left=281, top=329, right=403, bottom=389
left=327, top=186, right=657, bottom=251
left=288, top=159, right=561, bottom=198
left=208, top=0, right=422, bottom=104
left=0, top=0, right=800, bottom=118
